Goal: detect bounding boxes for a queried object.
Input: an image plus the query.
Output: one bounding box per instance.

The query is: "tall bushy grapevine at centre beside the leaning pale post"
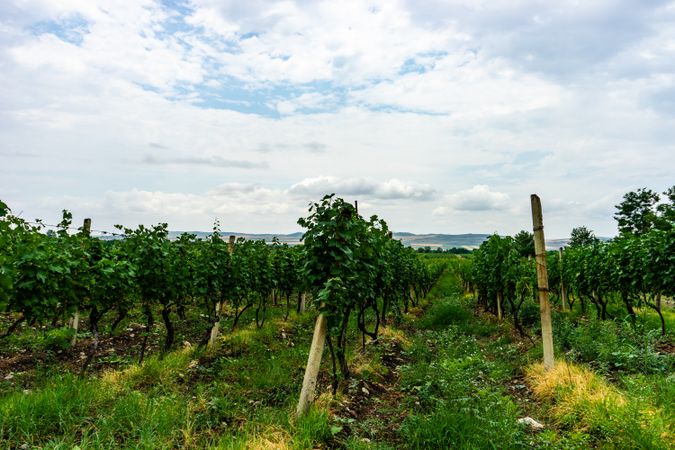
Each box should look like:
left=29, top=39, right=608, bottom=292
left=298, top=194, right=444, bottom=377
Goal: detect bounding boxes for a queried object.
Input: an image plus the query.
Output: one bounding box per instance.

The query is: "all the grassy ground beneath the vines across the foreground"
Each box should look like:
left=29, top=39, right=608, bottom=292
left=0, top=274, right=675, bottom=450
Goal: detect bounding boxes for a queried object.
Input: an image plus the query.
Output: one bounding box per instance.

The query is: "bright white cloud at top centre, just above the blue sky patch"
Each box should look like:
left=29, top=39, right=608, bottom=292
left=189, top=0, right=466, bottom=84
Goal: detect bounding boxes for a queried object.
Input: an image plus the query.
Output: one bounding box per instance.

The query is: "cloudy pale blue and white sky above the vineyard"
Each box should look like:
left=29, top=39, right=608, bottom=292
left=0, top=0, right=675, bottom=238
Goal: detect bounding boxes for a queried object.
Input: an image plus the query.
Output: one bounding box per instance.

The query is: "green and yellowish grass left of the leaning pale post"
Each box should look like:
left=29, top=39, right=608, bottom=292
left=0, top=304, right=332, bottom=449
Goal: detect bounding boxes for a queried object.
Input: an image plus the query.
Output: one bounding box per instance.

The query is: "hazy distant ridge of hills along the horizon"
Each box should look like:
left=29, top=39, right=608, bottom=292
left=169, top=231, right=596, bottom=250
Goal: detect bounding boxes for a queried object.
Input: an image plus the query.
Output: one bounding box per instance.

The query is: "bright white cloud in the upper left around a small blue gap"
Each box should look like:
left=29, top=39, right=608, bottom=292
left=9, top=1, right=204, bottom=93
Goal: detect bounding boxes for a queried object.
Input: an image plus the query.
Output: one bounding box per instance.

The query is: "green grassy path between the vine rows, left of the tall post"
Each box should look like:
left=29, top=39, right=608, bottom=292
left=400, top=277, right=527, bottom=449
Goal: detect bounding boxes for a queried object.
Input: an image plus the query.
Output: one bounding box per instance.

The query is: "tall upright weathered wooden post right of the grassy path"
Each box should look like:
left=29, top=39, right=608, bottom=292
left=530, top=194, right=554, bottom=370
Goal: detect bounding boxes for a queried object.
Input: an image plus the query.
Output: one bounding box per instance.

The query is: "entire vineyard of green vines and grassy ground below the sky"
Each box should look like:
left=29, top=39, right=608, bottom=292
left=0, top=195, right=675, bottom=448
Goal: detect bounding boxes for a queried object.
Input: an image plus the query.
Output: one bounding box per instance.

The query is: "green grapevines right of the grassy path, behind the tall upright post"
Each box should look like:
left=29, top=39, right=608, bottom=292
left=459, top=227, right=675, bottom=334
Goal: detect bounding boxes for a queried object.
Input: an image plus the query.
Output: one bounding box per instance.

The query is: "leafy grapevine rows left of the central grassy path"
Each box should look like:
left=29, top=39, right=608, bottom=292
left=0, top=197, right=439, bottom=374
